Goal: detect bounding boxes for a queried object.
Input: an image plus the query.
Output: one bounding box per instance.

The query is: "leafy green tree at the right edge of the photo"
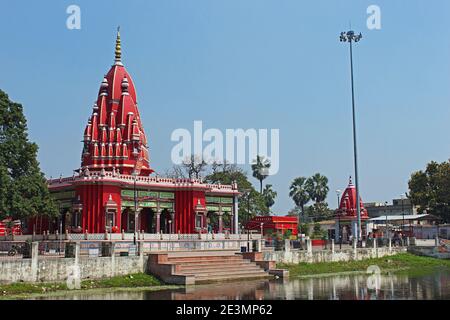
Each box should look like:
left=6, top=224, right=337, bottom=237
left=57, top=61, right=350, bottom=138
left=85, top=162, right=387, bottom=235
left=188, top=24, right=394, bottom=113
left=408, top=160, right=450, bottom=222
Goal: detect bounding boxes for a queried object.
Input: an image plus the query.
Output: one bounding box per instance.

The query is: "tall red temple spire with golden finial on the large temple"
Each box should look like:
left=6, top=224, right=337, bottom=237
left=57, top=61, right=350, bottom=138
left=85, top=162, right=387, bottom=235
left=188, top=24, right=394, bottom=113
left=81, top=31, right=153, bottom=175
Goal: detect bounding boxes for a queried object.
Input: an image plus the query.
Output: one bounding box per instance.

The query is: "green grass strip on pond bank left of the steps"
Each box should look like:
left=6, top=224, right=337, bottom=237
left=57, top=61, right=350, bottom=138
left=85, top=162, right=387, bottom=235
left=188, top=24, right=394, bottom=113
left=0, top=273, right=163, bottom=298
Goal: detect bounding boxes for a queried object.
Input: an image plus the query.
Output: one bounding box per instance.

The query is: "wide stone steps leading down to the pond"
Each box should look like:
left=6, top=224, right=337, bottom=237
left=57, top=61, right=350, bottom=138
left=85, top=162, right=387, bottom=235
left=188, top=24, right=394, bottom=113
left=148, top=251, right=282, bottom=285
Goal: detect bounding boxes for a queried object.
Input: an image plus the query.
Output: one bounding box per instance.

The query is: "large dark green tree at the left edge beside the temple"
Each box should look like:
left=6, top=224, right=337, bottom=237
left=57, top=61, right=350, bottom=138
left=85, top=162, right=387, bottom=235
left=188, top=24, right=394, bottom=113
left=0, top=90, right=58, bottom=219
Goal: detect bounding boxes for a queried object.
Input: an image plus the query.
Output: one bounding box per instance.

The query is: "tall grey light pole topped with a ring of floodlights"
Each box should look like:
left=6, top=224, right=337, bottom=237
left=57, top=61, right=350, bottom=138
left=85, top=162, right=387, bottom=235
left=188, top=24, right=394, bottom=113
left=340, top=31, right=362, bottom=241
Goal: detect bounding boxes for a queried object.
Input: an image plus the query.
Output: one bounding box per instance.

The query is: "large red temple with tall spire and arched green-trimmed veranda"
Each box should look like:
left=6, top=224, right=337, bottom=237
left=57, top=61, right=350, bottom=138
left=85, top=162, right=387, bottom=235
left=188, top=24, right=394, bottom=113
left=26, top=32, right=239, bottom=234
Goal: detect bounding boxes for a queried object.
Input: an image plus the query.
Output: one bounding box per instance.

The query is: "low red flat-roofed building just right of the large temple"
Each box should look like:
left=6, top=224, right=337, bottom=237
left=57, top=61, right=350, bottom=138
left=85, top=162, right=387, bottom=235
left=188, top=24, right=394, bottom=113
left=245, top=216, right=298, bottom=236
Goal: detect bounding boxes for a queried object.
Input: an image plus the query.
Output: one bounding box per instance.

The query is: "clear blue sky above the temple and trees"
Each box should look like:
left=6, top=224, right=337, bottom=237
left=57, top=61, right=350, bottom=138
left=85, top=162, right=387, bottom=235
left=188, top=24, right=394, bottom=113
left=0, top=0, right=450, bottom=213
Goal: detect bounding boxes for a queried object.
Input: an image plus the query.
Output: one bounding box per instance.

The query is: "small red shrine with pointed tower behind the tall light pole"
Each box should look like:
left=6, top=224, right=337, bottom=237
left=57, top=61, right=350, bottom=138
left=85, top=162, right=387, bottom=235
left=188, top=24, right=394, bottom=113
left=335, top=177, right=369, bottom=242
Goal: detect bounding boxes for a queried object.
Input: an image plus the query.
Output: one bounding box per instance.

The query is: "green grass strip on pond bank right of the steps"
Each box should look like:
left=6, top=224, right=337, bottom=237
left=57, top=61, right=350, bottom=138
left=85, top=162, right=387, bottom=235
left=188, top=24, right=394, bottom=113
left=277, top=253, right=450, bottom=277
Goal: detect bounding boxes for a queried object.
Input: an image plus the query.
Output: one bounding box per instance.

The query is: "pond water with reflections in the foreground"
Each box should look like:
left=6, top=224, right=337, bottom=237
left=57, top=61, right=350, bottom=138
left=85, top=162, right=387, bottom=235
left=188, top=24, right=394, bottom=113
left=37, top=271, right=450, bottom=300
